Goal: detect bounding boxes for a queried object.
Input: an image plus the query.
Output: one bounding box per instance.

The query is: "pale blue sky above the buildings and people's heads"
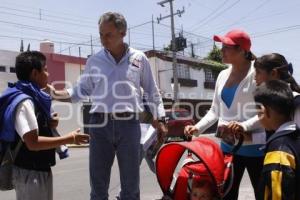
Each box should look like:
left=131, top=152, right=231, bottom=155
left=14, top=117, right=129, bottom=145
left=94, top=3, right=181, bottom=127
left=0, top=0, right=300, bottom=82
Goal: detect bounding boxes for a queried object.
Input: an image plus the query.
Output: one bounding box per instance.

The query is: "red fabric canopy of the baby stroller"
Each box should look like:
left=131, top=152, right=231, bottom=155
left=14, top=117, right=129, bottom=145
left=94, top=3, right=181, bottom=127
left=156, top=137, right=226, bottom=198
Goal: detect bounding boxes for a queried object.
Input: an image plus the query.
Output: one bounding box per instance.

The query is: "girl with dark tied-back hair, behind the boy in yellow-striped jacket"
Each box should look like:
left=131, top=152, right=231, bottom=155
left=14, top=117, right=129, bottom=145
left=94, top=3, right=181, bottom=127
left=254, top=53, right=300, bottom=127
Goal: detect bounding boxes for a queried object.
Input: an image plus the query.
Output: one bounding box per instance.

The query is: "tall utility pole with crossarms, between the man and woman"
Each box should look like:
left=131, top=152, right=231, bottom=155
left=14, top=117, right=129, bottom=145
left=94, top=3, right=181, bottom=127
left=157, top=0, right=184, bottom=104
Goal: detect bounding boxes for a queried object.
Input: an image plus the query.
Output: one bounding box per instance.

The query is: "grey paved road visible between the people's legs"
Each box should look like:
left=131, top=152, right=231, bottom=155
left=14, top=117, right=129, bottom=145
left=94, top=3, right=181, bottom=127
left=0, top=138, right=254, bottom=200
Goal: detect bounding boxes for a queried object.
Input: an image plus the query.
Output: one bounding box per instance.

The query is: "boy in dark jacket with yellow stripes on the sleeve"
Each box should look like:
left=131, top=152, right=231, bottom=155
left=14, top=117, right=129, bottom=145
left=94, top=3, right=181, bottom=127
left=254, top=80, right=300, bottom=200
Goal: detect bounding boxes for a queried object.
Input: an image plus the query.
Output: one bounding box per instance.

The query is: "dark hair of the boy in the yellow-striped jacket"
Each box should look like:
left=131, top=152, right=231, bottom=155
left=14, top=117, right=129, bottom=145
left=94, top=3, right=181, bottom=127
left=253, top=80, right=294, bottom=117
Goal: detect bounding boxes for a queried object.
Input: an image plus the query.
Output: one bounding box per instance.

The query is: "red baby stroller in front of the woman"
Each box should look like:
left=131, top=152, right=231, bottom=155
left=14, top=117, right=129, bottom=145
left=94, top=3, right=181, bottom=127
left=156, top=137, right=243, bottom=200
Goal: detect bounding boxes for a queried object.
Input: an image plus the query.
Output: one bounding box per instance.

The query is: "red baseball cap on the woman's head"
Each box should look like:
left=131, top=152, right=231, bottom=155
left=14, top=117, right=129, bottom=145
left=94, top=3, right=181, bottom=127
left=213, top=29, right=251, bottom=51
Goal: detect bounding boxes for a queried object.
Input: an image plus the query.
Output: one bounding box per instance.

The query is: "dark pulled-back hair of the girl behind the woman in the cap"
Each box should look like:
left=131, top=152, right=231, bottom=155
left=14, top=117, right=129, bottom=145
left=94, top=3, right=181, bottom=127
left=254, top=53, right=300, bottom=93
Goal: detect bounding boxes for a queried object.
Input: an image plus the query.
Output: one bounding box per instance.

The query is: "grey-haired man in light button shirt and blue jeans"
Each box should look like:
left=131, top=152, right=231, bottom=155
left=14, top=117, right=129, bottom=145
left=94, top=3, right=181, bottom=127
left=49, top=12, right=166, bottom=200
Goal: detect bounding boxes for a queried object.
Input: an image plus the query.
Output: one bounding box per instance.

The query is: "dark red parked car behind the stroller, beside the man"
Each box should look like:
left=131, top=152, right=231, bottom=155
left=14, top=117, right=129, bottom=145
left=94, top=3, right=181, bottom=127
left=166, top=108, right=195, bottom=137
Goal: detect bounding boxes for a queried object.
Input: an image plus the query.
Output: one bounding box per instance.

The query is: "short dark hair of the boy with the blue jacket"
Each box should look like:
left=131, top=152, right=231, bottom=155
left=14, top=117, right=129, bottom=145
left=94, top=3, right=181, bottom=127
left=15, top=51, right=46, bottom=81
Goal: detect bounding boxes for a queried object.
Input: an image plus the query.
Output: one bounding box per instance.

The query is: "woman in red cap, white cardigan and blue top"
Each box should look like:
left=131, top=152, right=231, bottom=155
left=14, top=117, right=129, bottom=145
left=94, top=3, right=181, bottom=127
left=185, top=30, right=265, bottom=200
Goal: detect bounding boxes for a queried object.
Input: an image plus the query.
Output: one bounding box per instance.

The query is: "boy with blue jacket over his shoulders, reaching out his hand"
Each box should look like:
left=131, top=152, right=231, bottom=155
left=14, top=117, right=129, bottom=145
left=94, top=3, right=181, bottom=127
left=0, top=51, right=89, bottom=200
